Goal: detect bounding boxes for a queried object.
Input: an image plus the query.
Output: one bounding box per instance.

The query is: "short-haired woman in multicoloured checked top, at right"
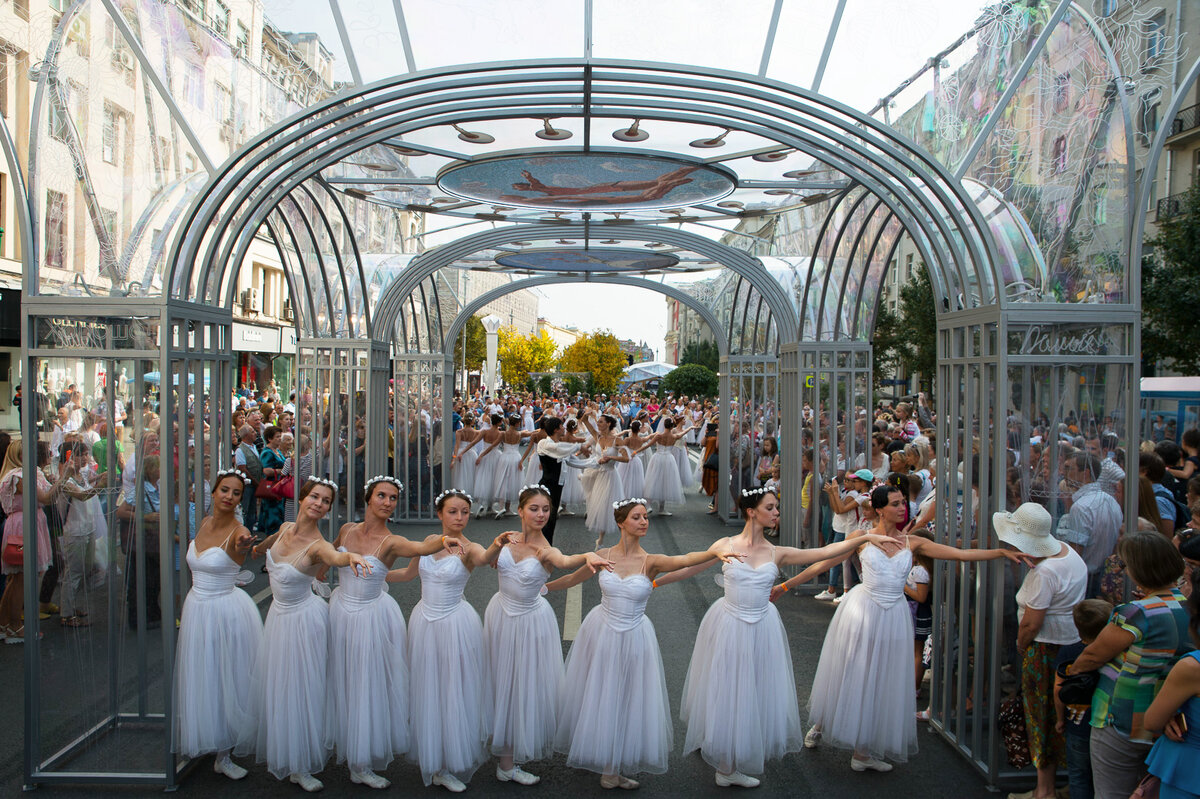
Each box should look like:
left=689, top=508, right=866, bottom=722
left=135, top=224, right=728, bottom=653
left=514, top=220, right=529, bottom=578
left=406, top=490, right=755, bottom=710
left=1070, top=531, right=1192, bottom=799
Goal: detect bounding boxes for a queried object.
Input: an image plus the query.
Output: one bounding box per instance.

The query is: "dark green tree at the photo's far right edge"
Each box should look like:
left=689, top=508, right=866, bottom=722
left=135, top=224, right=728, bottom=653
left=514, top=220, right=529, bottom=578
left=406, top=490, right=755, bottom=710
left=1141, top=182, right=1200, bottom=374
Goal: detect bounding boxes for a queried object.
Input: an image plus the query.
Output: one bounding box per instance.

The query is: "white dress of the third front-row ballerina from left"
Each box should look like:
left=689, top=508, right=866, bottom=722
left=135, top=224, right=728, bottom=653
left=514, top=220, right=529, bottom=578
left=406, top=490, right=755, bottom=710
left=325, top=547, right=409, bottom=771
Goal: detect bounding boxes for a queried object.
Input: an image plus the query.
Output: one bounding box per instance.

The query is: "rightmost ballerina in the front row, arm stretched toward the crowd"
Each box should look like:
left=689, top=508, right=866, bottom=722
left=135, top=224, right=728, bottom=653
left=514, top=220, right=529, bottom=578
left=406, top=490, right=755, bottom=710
left=792, top=486, right=1033, bottom=771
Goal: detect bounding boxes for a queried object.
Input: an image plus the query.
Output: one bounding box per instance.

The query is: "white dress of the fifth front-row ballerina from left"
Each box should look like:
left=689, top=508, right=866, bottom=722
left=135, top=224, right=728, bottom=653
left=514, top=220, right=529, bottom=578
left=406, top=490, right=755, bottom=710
left=484, top=547, right=563, bottom=763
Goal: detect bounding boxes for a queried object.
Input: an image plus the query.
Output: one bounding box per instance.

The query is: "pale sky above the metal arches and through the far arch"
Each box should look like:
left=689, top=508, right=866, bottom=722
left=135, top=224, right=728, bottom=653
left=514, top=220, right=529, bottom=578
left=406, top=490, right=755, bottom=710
left=265, top=0, right=990, bottom=356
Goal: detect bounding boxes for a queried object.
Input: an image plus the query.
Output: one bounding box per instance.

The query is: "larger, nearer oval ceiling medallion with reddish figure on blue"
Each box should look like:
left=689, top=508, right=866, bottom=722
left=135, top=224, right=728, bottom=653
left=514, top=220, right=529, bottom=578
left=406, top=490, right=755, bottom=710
left=438, top=151, right=737, bottom=211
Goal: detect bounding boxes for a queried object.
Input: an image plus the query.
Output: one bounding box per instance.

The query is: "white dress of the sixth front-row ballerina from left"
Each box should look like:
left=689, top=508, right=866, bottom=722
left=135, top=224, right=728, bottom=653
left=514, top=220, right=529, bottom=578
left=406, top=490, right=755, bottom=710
left=554, top=571, right=672, bottom=775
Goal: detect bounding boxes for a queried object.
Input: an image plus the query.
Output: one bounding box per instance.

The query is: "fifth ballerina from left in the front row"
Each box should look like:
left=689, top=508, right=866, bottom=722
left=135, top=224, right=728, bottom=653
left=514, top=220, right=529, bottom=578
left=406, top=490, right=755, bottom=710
left=484, top=485, right=612, bottom=785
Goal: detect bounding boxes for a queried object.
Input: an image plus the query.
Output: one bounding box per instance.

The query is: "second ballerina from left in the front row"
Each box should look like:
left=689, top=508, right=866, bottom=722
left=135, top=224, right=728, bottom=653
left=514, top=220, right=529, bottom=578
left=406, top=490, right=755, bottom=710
left=251, top=480, right=371, bottom=793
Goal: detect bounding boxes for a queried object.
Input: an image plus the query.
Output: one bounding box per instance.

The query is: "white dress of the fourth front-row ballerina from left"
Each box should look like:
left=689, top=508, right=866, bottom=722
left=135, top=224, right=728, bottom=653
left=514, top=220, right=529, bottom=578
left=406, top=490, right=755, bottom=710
left=408, top=555, right=492, bottom=786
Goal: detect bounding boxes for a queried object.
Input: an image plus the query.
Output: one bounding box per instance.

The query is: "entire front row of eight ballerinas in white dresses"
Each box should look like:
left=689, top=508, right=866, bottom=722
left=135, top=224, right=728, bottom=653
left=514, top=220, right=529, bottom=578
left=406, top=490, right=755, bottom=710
left=175, top=470, right=1021, bottom=792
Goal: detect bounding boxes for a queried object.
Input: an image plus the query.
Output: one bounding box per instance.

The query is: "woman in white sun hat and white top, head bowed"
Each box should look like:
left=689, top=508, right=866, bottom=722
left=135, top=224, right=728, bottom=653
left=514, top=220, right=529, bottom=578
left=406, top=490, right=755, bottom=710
left=991, top=503, right=1087, bottom=799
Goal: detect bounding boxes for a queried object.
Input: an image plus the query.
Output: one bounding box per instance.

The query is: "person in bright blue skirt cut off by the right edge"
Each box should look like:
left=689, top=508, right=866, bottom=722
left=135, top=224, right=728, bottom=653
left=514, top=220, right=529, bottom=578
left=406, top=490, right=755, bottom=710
left=1145, top=568, right=1200, bottom=799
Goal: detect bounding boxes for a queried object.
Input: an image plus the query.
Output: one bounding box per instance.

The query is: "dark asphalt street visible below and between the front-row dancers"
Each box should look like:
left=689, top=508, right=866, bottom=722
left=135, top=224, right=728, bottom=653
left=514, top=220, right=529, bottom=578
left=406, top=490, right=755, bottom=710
left=0, top=495, right=1012, bottom=799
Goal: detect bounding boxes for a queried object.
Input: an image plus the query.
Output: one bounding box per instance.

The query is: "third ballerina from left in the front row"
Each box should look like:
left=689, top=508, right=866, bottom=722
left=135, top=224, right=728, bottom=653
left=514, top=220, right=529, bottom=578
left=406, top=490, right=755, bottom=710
left=318, top=475, right=454, bottom=789
